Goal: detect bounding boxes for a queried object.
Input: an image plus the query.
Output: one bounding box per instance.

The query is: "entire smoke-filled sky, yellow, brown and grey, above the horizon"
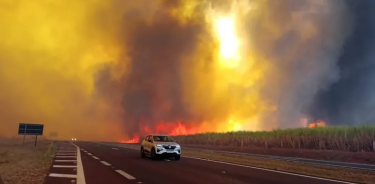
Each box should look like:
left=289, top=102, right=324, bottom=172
left=0, top=0, right=375, bottom=141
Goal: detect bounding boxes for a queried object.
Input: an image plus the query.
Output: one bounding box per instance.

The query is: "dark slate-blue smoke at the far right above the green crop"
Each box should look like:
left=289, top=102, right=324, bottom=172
left=310, top=0, right=375, bottom=125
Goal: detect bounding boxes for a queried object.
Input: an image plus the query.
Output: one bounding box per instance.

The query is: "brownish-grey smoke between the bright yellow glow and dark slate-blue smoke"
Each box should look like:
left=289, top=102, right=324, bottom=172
left=248, top=0, right=352, bottom=128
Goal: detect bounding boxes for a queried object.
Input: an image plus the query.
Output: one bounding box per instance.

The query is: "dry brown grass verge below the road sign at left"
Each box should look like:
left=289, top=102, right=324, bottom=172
left=0, top=138, right=56, bottom=184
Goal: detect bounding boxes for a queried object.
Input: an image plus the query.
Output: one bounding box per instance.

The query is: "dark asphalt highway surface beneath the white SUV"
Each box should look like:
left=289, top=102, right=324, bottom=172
left=45, top=142, right=358, bottom=184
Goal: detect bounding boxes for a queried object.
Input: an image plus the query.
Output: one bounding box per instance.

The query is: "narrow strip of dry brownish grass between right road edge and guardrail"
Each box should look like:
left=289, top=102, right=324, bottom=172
left=183, top=150, right=375, bottom=184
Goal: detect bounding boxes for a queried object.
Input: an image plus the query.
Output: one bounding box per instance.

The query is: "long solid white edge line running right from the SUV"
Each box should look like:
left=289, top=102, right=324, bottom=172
left=183, top=156, right=356, bottom=184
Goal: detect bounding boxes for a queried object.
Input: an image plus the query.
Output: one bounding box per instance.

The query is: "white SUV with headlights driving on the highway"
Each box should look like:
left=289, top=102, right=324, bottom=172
left=141, top=134, right=181, bottom=160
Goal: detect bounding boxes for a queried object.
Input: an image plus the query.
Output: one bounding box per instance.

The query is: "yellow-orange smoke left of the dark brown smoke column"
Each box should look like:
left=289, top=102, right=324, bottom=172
left=0, top=0, right=126, bottom=138
